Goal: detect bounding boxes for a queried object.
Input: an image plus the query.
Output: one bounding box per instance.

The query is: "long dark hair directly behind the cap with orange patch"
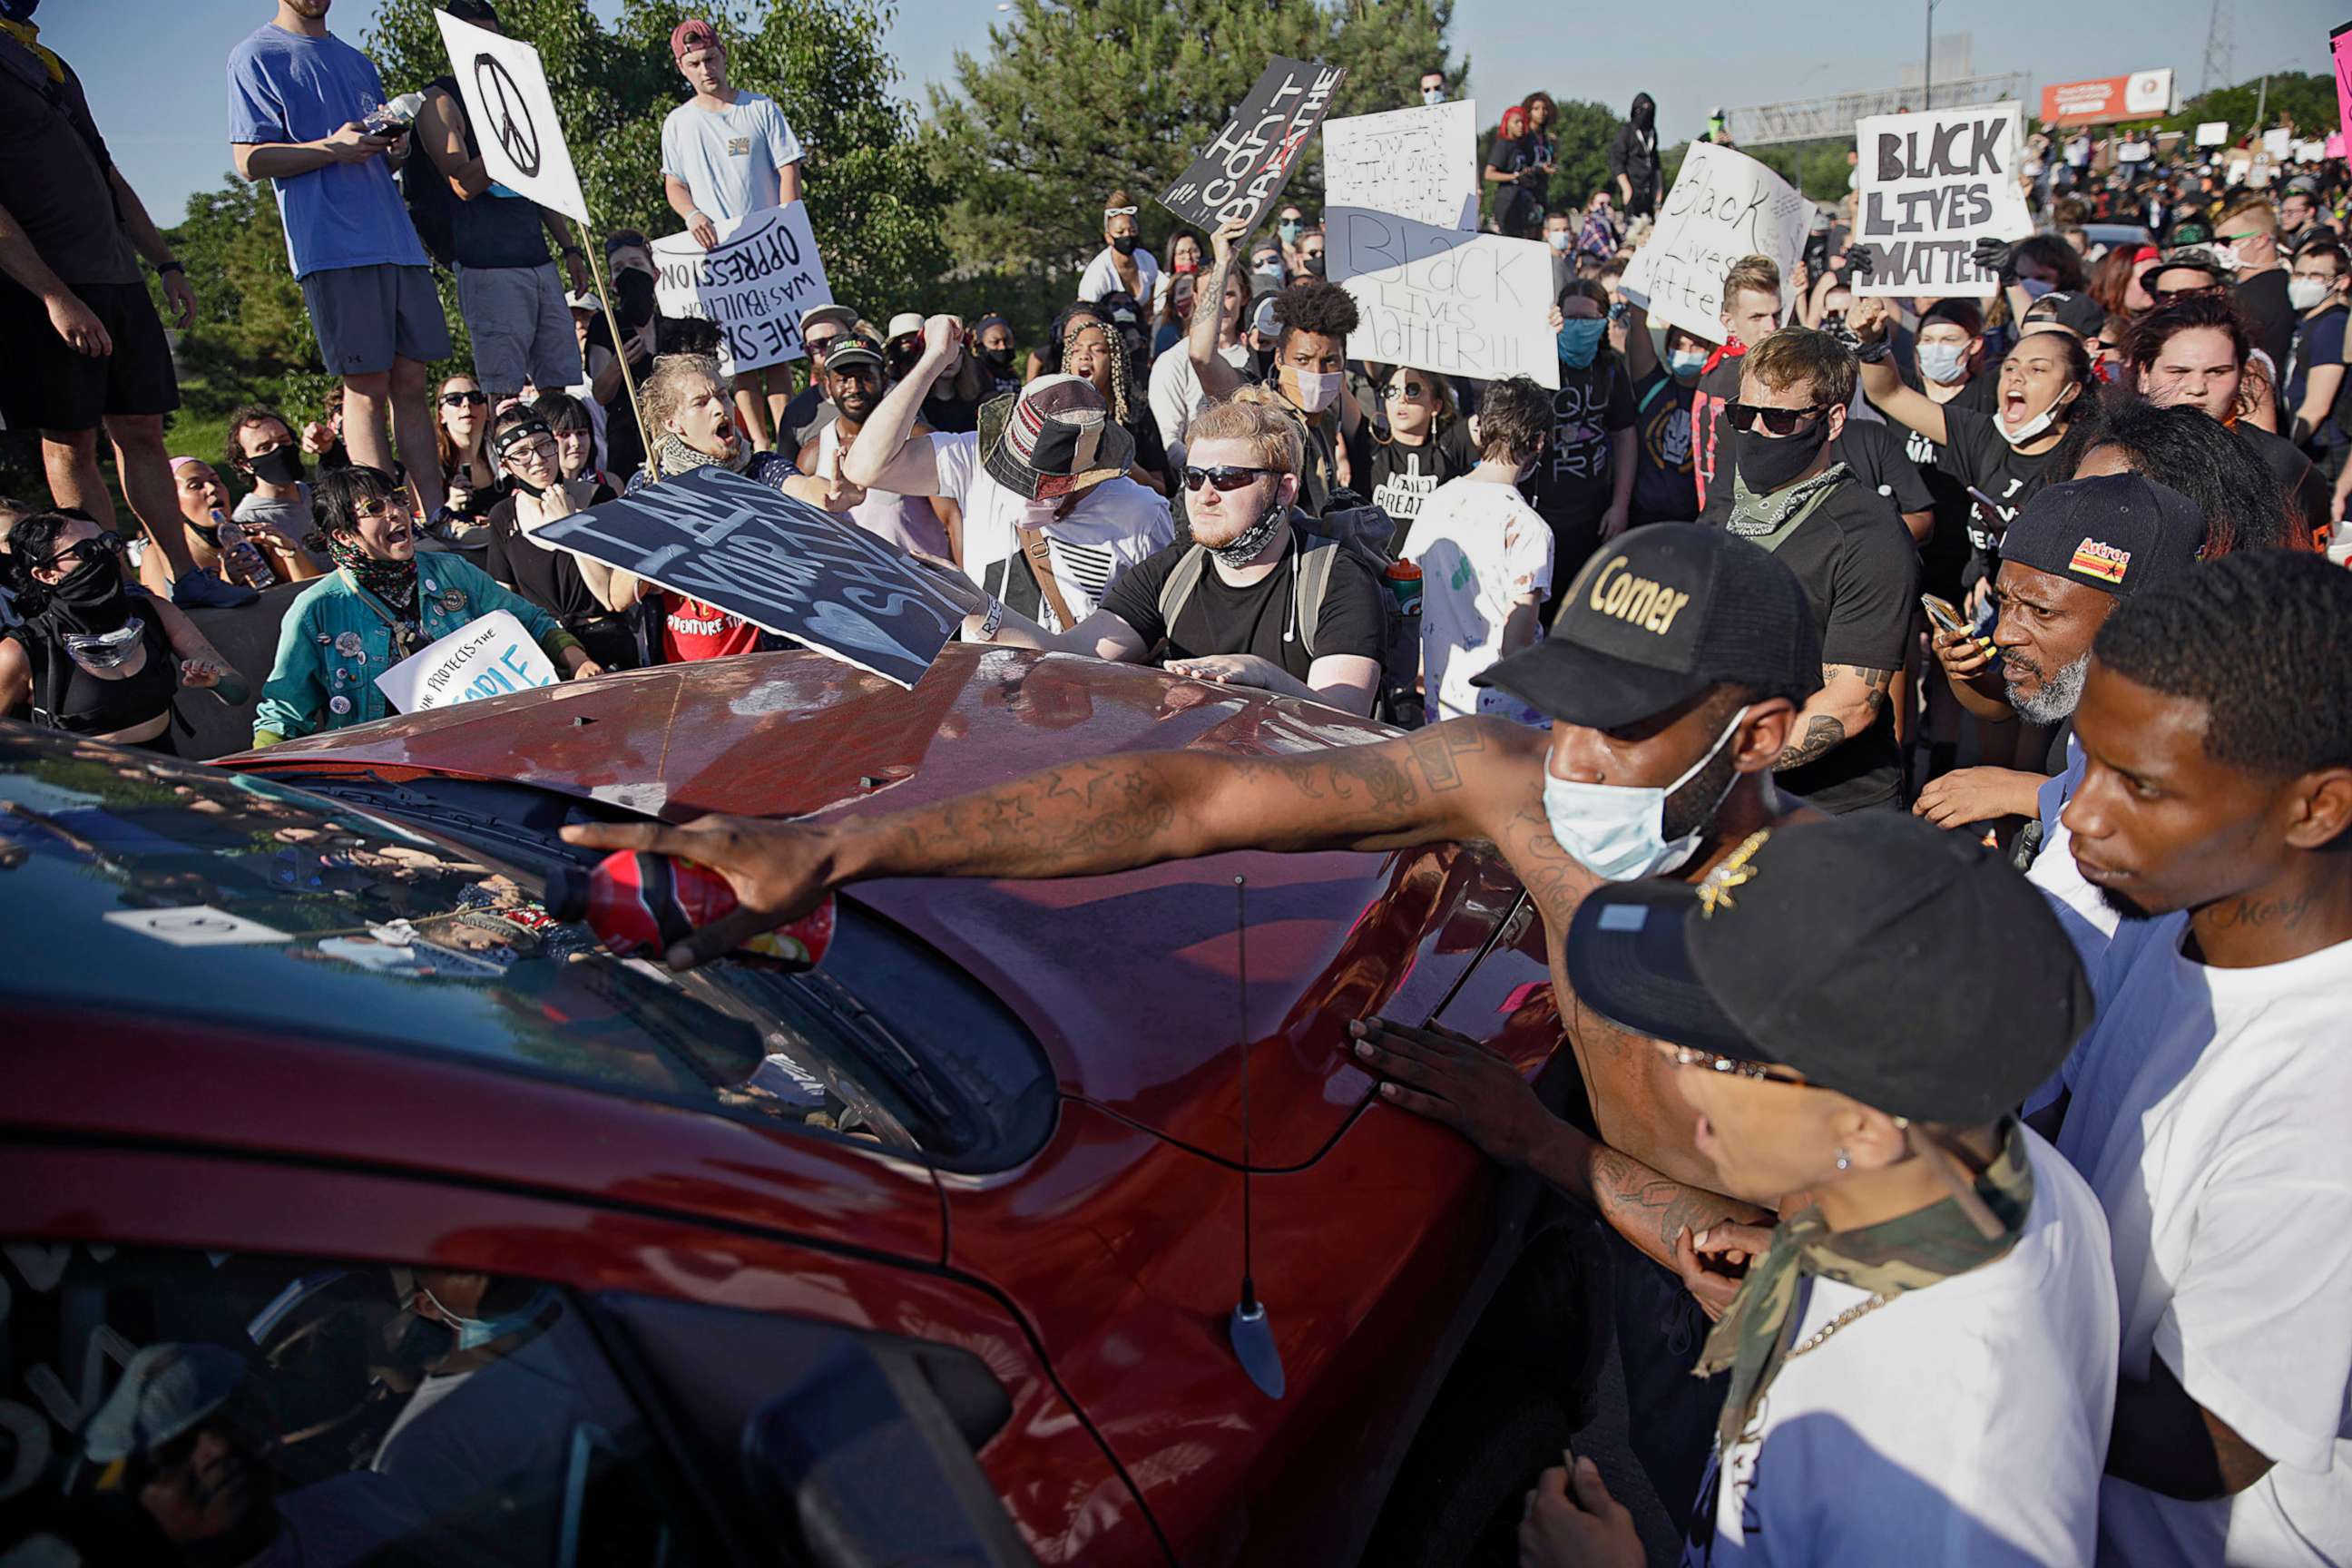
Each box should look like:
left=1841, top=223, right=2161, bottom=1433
left=2046, top=397, right=2303, bottom=562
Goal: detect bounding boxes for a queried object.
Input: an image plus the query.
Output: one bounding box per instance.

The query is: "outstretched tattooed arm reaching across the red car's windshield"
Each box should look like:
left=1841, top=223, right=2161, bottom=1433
left=564, top=720, right=1545, bottom=964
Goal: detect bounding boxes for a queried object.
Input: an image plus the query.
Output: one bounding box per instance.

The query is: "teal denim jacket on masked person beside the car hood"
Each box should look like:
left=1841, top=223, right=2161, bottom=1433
left=254, top=550, right=579, bottom=745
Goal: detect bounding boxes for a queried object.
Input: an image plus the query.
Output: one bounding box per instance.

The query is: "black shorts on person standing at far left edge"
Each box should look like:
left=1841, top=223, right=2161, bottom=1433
left=0, top=279, right=179, bottom=433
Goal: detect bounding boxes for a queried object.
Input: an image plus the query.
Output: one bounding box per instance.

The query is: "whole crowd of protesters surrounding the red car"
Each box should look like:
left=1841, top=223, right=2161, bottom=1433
left=0, top=0, right=2352, bottom=1565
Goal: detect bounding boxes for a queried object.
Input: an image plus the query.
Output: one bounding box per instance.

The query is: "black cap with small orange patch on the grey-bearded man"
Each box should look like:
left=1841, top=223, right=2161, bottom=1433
left=2002, top=473, right=2204, bottom=600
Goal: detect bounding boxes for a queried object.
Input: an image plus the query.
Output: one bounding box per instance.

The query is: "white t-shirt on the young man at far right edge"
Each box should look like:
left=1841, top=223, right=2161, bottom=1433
left=2058, top=915, right=2352, bottom=1568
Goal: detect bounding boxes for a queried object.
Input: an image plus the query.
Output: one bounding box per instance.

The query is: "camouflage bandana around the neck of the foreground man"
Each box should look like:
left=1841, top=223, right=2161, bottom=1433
left=1693, top=1117, right=2034, bottom=1448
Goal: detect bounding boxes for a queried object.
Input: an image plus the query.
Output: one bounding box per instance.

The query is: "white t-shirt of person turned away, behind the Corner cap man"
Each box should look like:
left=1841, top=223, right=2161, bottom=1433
left=1404, top=475, right=1553, bottom=724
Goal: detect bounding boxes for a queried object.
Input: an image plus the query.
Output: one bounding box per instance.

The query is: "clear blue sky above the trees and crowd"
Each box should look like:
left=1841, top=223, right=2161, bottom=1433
left=37, top=0, right=2352, bottom=226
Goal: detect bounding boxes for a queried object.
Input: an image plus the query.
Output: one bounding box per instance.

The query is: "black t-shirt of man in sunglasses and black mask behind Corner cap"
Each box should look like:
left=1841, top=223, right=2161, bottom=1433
left=1773, top=480, right=1919, bottom=816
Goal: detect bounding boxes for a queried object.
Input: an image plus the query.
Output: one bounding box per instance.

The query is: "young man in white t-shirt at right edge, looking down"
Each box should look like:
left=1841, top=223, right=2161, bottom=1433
left=2041, top=550, right=2352, bottom=1565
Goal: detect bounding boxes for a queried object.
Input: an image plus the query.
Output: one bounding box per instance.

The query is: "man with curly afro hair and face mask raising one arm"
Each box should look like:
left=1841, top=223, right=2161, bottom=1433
left=1185, top=211, right=1369, bottom=517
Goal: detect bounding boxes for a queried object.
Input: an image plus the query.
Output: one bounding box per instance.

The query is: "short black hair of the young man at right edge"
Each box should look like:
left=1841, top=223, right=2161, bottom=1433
left=2091, top=550, right=2352, bottom=779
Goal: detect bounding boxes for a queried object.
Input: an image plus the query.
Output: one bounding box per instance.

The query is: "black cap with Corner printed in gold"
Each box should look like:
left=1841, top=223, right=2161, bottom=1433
left=1473, top=522, right=1820, bottom=729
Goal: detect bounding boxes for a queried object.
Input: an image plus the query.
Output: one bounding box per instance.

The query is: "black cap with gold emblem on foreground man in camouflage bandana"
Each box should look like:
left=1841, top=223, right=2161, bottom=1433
left=1566, top=811, right=2091, bottom=1126
